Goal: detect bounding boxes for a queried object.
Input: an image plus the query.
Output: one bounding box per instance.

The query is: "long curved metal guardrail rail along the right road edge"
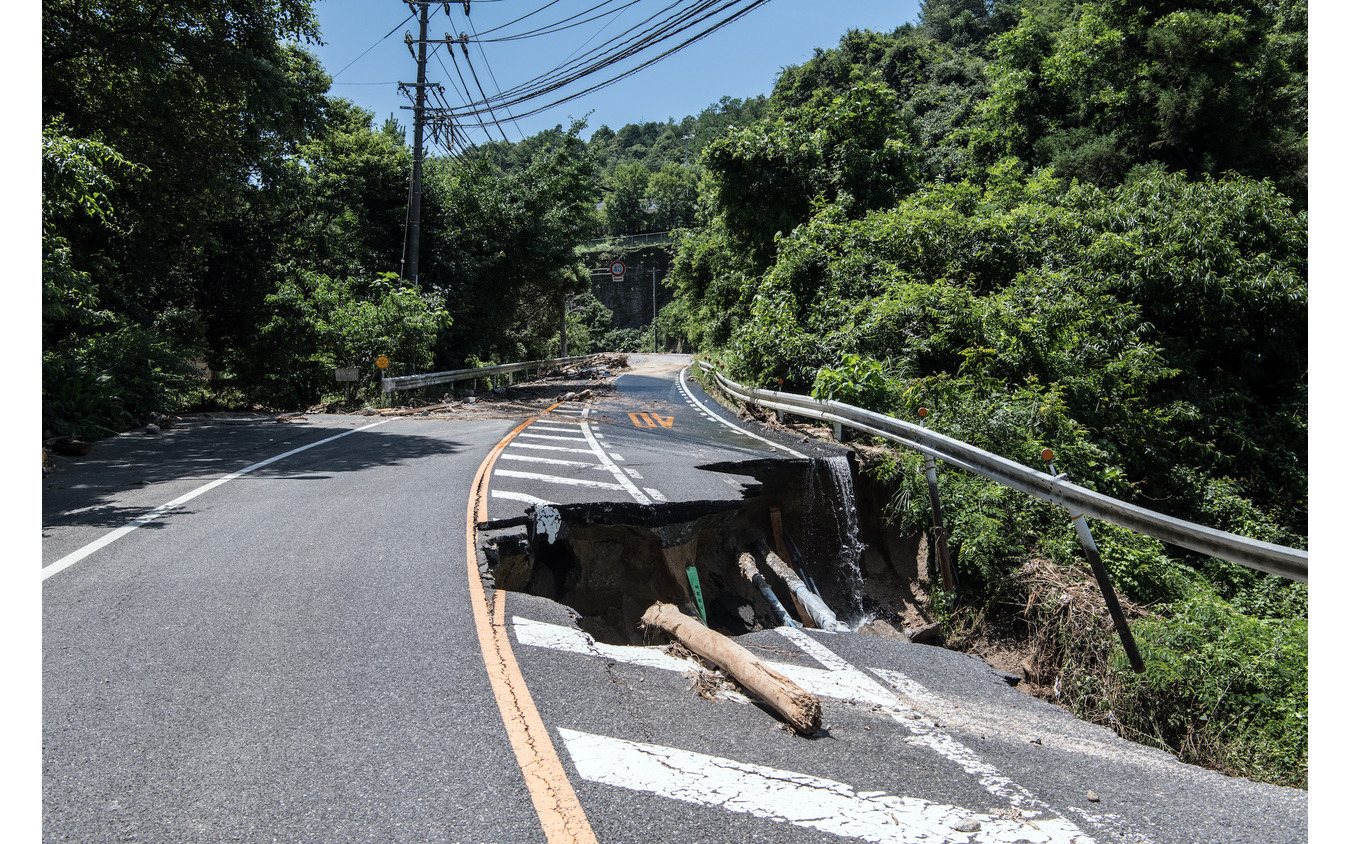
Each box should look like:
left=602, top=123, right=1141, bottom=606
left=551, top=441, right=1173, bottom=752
left=698, top=361, right=1308, bottom=583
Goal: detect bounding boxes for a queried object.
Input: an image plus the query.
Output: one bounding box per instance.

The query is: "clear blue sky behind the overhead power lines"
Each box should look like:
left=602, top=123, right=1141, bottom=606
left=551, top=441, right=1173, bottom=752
left=311, top=0, right=919, bottom=143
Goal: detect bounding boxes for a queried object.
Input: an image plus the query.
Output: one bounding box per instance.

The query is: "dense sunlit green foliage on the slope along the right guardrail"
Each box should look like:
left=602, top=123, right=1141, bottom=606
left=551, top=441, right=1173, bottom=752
left=674, top=0, right=1308, bottom=785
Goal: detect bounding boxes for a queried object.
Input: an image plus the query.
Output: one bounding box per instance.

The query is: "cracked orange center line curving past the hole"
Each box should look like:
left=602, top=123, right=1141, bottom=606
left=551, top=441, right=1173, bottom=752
left=466, top=404, right=597, bottom=844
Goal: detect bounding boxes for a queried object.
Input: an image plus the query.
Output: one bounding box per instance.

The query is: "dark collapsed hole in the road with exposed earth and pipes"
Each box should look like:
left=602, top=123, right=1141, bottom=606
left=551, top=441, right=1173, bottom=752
left=481, top=450, right=926, bottom=644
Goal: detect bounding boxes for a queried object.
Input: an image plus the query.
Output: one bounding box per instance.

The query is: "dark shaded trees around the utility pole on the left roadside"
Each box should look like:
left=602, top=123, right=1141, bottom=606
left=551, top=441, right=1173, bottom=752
left=43, top=0, right=607, bottom=418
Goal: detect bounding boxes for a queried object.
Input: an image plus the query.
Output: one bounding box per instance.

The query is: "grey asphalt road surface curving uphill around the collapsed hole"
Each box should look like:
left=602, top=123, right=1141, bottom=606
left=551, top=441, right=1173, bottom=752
left=42, top=359, right=1308, bottom=844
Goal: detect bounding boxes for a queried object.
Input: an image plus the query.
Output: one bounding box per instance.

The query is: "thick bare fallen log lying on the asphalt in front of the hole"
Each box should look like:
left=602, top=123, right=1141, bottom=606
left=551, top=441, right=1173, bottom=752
left=643, top=601, right=821, bottom=736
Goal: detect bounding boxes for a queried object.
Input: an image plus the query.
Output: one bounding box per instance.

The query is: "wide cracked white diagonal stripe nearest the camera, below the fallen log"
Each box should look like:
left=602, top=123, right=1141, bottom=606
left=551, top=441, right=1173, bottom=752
left=558, top=729, right=1083, bottom=844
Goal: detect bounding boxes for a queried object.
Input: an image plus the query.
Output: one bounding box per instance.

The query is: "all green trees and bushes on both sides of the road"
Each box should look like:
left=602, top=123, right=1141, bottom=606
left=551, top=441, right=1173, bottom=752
left=42, top=0, right=1308, bottom=787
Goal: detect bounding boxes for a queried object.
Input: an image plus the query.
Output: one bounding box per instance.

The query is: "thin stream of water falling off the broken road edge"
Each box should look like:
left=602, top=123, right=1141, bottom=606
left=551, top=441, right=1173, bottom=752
left=807, top=455, right=871, bottom=629
